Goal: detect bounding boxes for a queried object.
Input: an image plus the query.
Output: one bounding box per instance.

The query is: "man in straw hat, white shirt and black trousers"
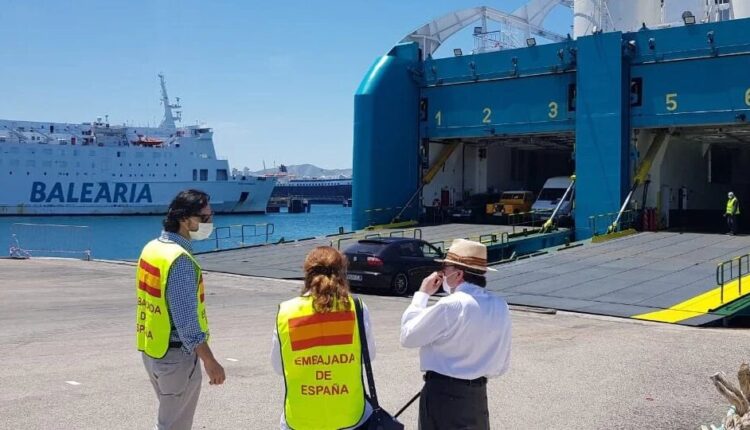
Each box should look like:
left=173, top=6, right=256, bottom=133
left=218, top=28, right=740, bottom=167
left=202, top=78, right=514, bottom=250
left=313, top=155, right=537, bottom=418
left=401, top=239, right=511, bottom=430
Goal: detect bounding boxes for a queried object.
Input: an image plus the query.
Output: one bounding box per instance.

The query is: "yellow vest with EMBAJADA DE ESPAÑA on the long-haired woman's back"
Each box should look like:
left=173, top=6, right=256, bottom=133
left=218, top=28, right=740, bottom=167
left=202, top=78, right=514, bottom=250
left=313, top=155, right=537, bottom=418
left=276, top=296, right=365, bottom=430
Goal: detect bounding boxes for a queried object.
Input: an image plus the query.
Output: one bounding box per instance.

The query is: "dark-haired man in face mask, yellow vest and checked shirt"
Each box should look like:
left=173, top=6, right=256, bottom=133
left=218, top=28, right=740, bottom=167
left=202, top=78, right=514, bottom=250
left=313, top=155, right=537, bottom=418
left=136, top=190, right=225, bottom=430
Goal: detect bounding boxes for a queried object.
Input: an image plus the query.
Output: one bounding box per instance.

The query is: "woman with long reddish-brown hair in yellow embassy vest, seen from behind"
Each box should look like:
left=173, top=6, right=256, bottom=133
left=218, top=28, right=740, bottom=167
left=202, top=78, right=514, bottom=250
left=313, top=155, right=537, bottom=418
left=271, top=246, right=375, bottom=430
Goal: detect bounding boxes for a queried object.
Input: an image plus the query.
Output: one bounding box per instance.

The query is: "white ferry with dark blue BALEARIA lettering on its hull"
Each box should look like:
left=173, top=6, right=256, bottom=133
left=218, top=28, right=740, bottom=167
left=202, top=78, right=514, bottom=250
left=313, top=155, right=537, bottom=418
left=0, top=74, right=276, bottom=216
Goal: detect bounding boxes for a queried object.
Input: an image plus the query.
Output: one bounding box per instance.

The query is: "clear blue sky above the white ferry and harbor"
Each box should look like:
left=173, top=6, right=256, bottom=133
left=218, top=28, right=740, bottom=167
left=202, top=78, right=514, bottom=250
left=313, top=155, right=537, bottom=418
left=0, top=0, right=572, bottom=170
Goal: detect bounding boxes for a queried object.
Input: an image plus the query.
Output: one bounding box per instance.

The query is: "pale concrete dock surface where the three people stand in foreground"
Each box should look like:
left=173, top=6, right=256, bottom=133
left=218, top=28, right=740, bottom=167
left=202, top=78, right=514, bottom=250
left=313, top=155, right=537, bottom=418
left=0, top=259, right=750, bottom=430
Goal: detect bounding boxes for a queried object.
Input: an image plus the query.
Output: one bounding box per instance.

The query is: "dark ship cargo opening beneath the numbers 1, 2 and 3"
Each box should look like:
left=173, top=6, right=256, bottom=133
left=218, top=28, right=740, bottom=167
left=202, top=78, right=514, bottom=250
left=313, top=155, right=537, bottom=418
left=422, top=133, right=575, bottom=225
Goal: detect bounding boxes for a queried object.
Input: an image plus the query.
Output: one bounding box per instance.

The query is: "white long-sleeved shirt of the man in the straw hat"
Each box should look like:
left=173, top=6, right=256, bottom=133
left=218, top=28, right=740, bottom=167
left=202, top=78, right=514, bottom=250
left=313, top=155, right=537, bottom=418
left=401, top=282, right=511, bottom=379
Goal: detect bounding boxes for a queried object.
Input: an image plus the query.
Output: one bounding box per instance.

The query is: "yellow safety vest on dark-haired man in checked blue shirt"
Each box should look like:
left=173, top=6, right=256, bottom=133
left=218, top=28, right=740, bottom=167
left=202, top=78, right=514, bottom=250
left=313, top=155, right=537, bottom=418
left=135, top=239, right=208, bottom=358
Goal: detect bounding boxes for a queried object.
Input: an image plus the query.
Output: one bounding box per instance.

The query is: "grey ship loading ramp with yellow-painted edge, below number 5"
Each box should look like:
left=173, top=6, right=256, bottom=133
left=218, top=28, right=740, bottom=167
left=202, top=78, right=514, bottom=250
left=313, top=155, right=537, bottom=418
left=494, top=232, right=750, bottom=326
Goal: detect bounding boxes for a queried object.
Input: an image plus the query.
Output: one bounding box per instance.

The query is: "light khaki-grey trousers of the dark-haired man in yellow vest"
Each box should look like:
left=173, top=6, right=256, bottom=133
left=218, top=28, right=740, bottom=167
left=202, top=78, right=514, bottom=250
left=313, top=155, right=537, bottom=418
left=143, top=348, right=202, bottom=430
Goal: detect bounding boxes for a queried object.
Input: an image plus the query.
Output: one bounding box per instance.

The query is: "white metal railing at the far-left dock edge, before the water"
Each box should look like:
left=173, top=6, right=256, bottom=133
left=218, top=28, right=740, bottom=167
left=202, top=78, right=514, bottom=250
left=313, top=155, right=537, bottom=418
left=8, top=223, right=92, bottom=260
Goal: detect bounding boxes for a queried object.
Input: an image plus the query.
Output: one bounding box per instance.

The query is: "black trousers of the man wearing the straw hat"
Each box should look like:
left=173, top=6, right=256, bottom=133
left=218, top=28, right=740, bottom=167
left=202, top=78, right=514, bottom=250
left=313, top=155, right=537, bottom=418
left=419, top=373, right=490, bottom=430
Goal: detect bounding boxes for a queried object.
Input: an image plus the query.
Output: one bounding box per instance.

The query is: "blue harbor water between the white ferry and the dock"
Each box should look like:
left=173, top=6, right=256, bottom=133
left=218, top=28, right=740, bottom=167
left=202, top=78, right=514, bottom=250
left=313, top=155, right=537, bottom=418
left=0, top=204, right=352, bottom=260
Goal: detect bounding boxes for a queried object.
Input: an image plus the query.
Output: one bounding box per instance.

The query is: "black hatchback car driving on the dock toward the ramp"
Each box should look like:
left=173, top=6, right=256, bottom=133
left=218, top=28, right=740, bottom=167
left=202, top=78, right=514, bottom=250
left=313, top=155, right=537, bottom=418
left=344, top=237, right=443, bottom=296
